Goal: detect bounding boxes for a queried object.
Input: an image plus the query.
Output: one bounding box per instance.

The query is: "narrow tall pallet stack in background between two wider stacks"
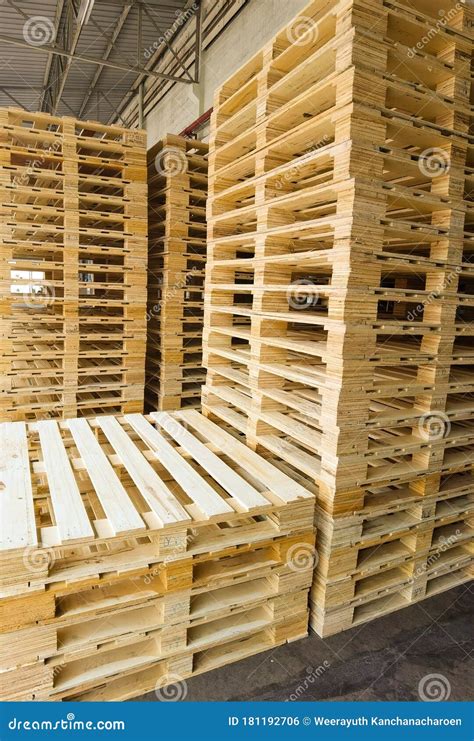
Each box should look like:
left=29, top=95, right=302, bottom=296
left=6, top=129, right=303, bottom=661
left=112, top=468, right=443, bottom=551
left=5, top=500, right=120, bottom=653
left=145, top=134, right=208, bottom=410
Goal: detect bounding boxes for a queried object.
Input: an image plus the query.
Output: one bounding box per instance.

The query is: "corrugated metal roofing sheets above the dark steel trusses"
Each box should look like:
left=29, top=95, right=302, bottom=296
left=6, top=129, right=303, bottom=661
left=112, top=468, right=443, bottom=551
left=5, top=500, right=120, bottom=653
left=0, top=0, right=198, bottom=122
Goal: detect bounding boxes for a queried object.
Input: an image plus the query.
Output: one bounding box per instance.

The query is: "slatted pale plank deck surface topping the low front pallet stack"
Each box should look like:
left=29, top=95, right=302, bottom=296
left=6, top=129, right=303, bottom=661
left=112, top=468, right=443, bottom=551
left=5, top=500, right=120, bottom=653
left=0, top=410, right=313, bottom=552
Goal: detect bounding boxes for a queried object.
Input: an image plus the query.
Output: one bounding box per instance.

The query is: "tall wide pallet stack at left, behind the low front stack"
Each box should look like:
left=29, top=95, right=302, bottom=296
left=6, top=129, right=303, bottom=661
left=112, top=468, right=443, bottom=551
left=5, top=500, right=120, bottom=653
left=0, top=109, right=147, bottom=420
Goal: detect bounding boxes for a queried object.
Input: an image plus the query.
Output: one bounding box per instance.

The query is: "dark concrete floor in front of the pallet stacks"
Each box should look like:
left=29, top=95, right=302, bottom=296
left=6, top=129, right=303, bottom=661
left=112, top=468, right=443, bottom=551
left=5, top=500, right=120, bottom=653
left=138, top=582, right=474, bottom=702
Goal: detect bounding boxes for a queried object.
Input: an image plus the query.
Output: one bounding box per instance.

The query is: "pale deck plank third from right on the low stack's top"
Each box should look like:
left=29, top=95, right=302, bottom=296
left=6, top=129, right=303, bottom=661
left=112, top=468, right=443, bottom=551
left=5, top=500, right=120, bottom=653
left=124, top=414, right=234, bottom=517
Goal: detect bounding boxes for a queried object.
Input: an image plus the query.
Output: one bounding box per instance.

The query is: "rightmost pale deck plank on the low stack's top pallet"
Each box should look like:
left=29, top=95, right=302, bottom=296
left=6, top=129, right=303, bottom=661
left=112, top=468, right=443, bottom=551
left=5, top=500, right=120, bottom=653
left=180, top=409, right=313, bottom=502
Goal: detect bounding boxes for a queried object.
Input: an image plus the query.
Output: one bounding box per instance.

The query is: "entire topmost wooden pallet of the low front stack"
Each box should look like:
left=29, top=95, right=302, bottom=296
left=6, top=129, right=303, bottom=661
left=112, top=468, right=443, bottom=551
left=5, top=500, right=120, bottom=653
left=0, top=411, right=314, bottom=593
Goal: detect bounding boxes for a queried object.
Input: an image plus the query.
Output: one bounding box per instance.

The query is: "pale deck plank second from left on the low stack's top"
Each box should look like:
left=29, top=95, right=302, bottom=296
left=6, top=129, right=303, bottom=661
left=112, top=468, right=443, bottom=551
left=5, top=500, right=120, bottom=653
left=36, top=420, right=94, bottom=543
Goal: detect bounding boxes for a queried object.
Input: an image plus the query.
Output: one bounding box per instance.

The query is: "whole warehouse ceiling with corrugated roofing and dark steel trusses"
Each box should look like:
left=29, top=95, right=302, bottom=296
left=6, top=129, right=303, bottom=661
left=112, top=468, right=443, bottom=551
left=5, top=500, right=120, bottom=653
left=0, top=0, right=245, bottom=123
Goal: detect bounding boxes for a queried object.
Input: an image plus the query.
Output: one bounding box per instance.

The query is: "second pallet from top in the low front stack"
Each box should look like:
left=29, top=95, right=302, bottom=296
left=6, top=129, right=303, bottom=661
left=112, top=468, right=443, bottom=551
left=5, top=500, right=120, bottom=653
left=0, top=529, right=314, bottom=636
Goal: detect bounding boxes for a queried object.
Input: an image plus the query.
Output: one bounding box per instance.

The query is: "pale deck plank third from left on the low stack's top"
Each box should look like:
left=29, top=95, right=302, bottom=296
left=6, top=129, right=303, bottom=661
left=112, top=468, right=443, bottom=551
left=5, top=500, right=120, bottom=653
left=67, top=419, right=145, bottom=535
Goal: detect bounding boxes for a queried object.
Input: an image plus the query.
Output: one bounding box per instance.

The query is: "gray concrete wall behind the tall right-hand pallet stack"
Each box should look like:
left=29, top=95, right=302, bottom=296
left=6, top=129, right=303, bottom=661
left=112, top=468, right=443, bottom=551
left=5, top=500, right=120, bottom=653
left=145, top=0, right=308, bottom=147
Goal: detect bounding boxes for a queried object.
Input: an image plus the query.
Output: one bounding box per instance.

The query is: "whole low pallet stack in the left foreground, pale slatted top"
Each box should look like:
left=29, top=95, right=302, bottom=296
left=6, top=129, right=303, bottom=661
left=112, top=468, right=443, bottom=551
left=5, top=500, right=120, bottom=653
left=0, top=410, right=314, bottom=700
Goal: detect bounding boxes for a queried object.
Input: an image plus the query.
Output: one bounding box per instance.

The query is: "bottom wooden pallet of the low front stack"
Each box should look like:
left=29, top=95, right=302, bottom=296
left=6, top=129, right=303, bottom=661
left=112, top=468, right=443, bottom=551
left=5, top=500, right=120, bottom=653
left=2, top=592, right=308, bottom=702
